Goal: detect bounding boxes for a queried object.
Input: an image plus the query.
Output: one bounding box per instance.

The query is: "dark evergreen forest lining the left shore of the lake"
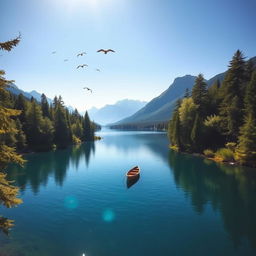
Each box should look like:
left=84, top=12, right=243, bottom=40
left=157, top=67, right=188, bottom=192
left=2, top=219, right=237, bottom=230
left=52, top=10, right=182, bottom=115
left=0, top=90, right=99, bottom=152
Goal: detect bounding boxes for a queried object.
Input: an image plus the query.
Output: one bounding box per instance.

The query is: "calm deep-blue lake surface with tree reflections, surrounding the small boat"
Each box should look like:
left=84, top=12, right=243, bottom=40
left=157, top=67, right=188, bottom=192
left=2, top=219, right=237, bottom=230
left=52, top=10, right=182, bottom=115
left=0, top=131, right=256, bottom=256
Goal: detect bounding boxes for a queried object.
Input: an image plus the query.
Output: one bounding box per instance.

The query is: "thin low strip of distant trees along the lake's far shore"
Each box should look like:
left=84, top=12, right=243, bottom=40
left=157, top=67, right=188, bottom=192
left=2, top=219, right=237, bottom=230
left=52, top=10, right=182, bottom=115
left=110, top=122, right=168, bottom=131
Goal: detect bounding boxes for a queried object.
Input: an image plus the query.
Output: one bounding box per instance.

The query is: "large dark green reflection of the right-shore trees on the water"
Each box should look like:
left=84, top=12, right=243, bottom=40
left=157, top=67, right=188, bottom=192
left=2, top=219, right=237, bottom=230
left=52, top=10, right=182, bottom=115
left=169, top=152, right=256, bottom=248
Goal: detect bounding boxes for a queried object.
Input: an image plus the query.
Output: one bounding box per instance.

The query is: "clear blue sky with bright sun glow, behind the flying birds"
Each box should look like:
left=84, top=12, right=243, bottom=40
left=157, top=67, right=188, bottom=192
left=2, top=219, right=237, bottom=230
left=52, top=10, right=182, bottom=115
left=0, top=0, right=256, bottom=111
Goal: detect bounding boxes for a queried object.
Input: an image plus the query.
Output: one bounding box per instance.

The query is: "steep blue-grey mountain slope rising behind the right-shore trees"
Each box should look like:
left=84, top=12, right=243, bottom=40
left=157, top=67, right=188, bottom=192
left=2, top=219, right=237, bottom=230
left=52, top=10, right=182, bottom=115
left=111, top=57, right=256, bottom=128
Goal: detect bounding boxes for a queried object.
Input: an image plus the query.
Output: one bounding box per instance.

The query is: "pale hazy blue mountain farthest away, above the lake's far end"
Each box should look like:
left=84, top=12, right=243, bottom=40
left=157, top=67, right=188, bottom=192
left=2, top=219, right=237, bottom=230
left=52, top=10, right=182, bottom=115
left=88, top=99, right=147, bottom=125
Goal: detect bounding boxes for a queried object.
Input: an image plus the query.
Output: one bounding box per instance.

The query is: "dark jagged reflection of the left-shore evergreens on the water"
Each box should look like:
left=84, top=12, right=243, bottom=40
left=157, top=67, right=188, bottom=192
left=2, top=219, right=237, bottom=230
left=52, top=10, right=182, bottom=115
left=8, top=142, right=95, bottom=193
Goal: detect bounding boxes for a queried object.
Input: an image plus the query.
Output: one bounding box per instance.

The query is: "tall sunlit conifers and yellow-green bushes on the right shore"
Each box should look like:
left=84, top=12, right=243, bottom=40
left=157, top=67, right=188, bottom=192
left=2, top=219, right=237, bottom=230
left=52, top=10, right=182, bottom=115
left=168, top=50, right=256, bottom=167
